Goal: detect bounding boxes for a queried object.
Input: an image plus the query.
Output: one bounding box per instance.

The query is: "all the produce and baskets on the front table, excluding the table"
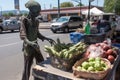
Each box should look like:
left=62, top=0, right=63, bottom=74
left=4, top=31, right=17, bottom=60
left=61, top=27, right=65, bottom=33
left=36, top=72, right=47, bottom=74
left=45, top=39, right=119, bottom=80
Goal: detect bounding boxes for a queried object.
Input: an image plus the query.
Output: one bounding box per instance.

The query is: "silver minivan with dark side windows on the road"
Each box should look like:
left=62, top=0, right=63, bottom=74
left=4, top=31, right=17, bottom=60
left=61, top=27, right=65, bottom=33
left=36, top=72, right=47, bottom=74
left=50, top=16, right=83, bottom=33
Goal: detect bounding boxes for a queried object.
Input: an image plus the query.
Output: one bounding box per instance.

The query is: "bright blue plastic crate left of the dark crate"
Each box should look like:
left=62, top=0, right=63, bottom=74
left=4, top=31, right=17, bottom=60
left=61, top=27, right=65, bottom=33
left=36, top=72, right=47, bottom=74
left=70, top=32, right=84, bottom=44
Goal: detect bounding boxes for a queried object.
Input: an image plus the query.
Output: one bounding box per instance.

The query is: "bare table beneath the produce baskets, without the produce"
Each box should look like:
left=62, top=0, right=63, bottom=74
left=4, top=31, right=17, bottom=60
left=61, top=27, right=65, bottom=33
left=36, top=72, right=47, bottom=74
left=32, top=55, right=120, bottom=80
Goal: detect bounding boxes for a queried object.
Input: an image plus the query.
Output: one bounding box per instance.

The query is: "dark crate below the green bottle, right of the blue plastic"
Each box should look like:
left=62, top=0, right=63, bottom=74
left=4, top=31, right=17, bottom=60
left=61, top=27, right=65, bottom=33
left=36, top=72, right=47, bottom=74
left=84, top=33, right=105, bottom=44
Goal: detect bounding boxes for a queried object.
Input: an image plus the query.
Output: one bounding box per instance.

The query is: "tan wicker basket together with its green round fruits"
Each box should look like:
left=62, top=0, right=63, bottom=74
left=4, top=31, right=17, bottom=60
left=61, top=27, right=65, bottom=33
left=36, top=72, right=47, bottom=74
left=72, top=57, right=111, bottom=80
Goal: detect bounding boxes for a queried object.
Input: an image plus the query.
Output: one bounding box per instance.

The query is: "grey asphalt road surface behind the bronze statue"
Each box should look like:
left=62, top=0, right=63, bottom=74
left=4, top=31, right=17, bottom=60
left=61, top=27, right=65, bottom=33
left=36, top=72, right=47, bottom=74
left=0, top=29, right=70, bottom=80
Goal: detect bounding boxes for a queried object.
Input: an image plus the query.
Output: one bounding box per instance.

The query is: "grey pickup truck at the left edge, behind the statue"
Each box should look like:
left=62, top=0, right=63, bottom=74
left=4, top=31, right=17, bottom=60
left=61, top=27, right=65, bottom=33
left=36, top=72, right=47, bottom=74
left=0, top=19, right=20, bottom=33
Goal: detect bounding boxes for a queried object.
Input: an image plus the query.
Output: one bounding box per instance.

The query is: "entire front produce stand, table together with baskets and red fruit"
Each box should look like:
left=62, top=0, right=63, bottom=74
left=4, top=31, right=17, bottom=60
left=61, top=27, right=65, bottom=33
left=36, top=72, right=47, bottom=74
left=32, top=39, right=120, bottom=80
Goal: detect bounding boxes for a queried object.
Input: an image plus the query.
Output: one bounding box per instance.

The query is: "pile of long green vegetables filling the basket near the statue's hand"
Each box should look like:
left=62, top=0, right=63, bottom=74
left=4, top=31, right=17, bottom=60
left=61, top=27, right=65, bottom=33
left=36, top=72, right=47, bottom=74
left=45, top=39, right=87, bottom=59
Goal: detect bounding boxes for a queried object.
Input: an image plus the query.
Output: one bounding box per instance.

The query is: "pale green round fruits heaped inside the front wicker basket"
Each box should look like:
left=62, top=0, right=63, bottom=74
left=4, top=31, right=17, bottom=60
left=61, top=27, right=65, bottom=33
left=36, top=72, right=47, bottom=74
left=77, top=57, right=108, bottom=72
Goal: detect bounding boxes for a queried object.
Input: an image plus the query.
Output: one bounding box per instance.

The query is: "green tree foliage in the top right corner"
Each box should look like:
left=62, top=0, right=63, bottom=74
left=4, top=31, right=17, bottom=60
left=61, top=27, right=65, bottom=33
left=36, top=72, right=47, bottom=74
left=104, top=0, right=120, bottom=14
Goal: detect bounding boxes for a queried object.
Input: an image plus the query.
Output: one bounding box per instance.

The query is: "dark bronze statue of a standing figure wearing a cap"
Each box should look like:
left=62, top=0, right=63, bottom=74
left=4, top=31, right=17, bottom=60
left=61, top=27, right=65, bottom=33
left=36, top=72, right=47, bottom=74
left=20, top=0, right=54, bottom=80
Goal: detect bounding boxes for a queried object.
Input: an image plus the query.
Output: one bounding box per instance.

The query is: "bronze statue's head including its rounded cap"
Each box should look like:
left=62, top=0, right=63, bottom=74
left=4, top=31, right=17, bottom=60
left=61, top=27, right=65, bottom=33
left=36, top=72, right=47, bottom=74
left=25, top=0, right=41, bottom=17
